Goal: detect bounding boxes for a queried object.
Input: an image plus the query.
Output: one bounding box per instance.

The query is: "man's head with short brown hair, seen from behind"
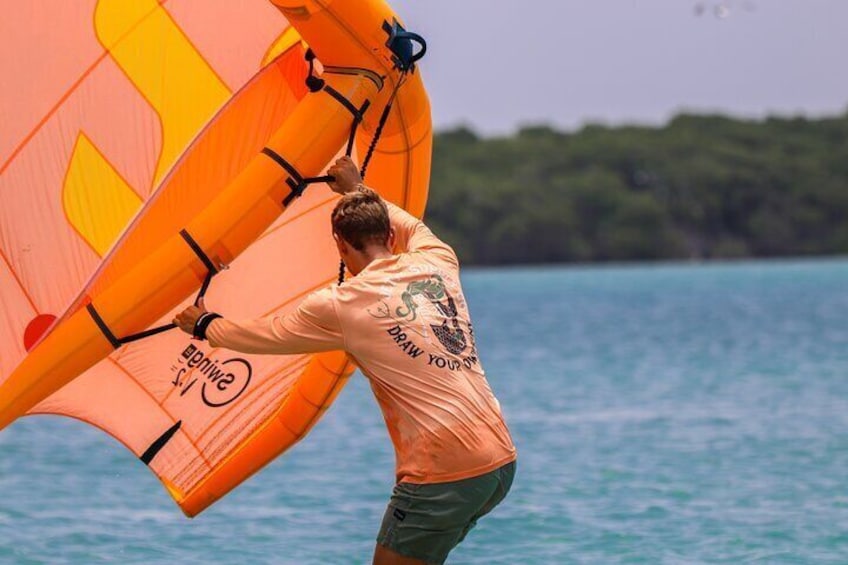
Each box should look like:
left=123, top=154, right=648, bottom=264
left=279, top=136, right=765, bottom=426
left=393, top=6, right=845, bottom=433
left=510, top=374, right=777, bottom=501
left=332, top=187, right=394, bottom=275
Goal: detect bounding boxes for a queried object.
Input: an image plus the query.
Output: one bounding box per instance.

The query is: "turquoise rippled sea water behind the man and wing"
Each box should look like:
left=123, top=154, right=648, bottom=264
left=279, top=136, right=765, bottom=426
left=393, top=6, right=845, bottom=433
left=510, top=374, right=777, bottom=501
left=0, top=260, right=848, bottom=564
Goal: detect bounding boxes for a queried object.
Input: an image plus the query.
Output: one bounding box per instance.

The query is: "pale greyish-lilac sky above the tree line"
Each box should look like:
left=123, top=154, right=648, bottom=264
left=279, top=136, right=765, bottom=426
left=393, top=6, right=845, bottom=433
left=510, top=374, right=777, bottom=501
left=391, top=0, right=848, bottom=135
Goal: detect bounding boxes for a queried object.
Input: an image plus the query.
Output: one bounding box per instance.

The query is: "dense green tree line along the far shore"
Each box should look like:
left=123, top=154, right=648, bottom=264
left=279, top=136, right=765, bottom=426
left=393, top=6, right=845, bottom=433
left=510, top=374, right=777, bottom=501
left=426, top=114, right=848, bottom=264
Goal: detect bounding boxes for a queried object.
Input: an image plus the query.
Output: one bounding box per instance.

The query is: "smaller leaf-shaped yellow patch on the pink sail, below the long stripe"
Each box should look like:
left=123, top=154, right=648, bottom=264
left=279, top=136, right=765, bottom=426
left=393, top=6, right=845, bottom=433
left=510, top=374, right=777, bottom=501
left=62, top=133, right=142, bottom=257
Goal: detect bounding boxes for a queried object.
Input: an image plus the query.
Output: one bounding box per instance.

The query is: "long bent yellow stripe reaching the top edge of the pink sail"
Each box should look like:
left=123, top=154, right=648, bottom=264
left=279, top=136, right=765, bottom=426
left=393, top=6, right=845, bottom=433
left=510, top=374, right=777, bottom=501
left=94, top=0, right=230, bottom=184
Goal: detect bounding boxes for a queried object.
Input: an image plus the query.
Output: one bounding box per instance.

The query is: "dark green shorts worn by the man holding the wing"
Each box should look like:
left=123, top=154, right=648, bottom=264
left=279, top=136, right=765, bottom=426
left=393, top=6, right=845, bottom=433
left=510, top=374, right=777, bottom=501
left=377, top=461, right=515, bottom=564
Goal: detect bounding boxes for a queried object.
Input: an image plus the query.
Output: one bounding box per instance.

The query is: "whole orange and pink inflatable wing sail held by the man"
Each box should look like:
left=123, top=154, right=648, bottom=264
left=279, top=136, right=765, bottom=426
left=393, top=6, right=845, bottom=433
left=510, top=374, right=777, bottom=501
left=0, top=0, right=432, bottom=516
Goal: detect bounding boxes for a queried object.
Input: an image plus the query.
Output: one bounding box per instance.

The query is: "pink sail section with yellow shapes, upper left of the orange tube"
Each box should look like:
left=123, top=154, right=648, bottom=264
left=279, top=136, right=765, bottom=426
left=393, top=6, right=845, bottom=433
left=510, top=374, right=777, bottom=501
left=0, top=0, right=288, bottom=383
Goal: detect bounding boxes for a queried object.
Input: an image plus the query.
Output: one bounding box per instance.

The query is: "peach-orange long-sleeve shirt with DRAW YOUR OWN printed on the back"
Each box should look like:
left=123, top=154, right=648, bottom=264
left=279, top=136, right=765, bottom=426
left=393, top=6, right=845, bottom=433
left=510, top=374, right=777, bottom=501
left=206, top=203, right=516, bottom=483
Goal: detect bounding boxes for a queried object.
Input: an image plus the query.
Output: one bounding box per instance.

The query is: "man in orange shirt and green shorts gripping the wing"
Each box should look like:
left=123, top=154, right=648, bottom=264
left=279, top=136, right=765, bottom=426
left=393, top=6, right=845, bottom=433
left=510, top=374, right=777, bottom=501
left=174, top=157, right=516, bottom=565
